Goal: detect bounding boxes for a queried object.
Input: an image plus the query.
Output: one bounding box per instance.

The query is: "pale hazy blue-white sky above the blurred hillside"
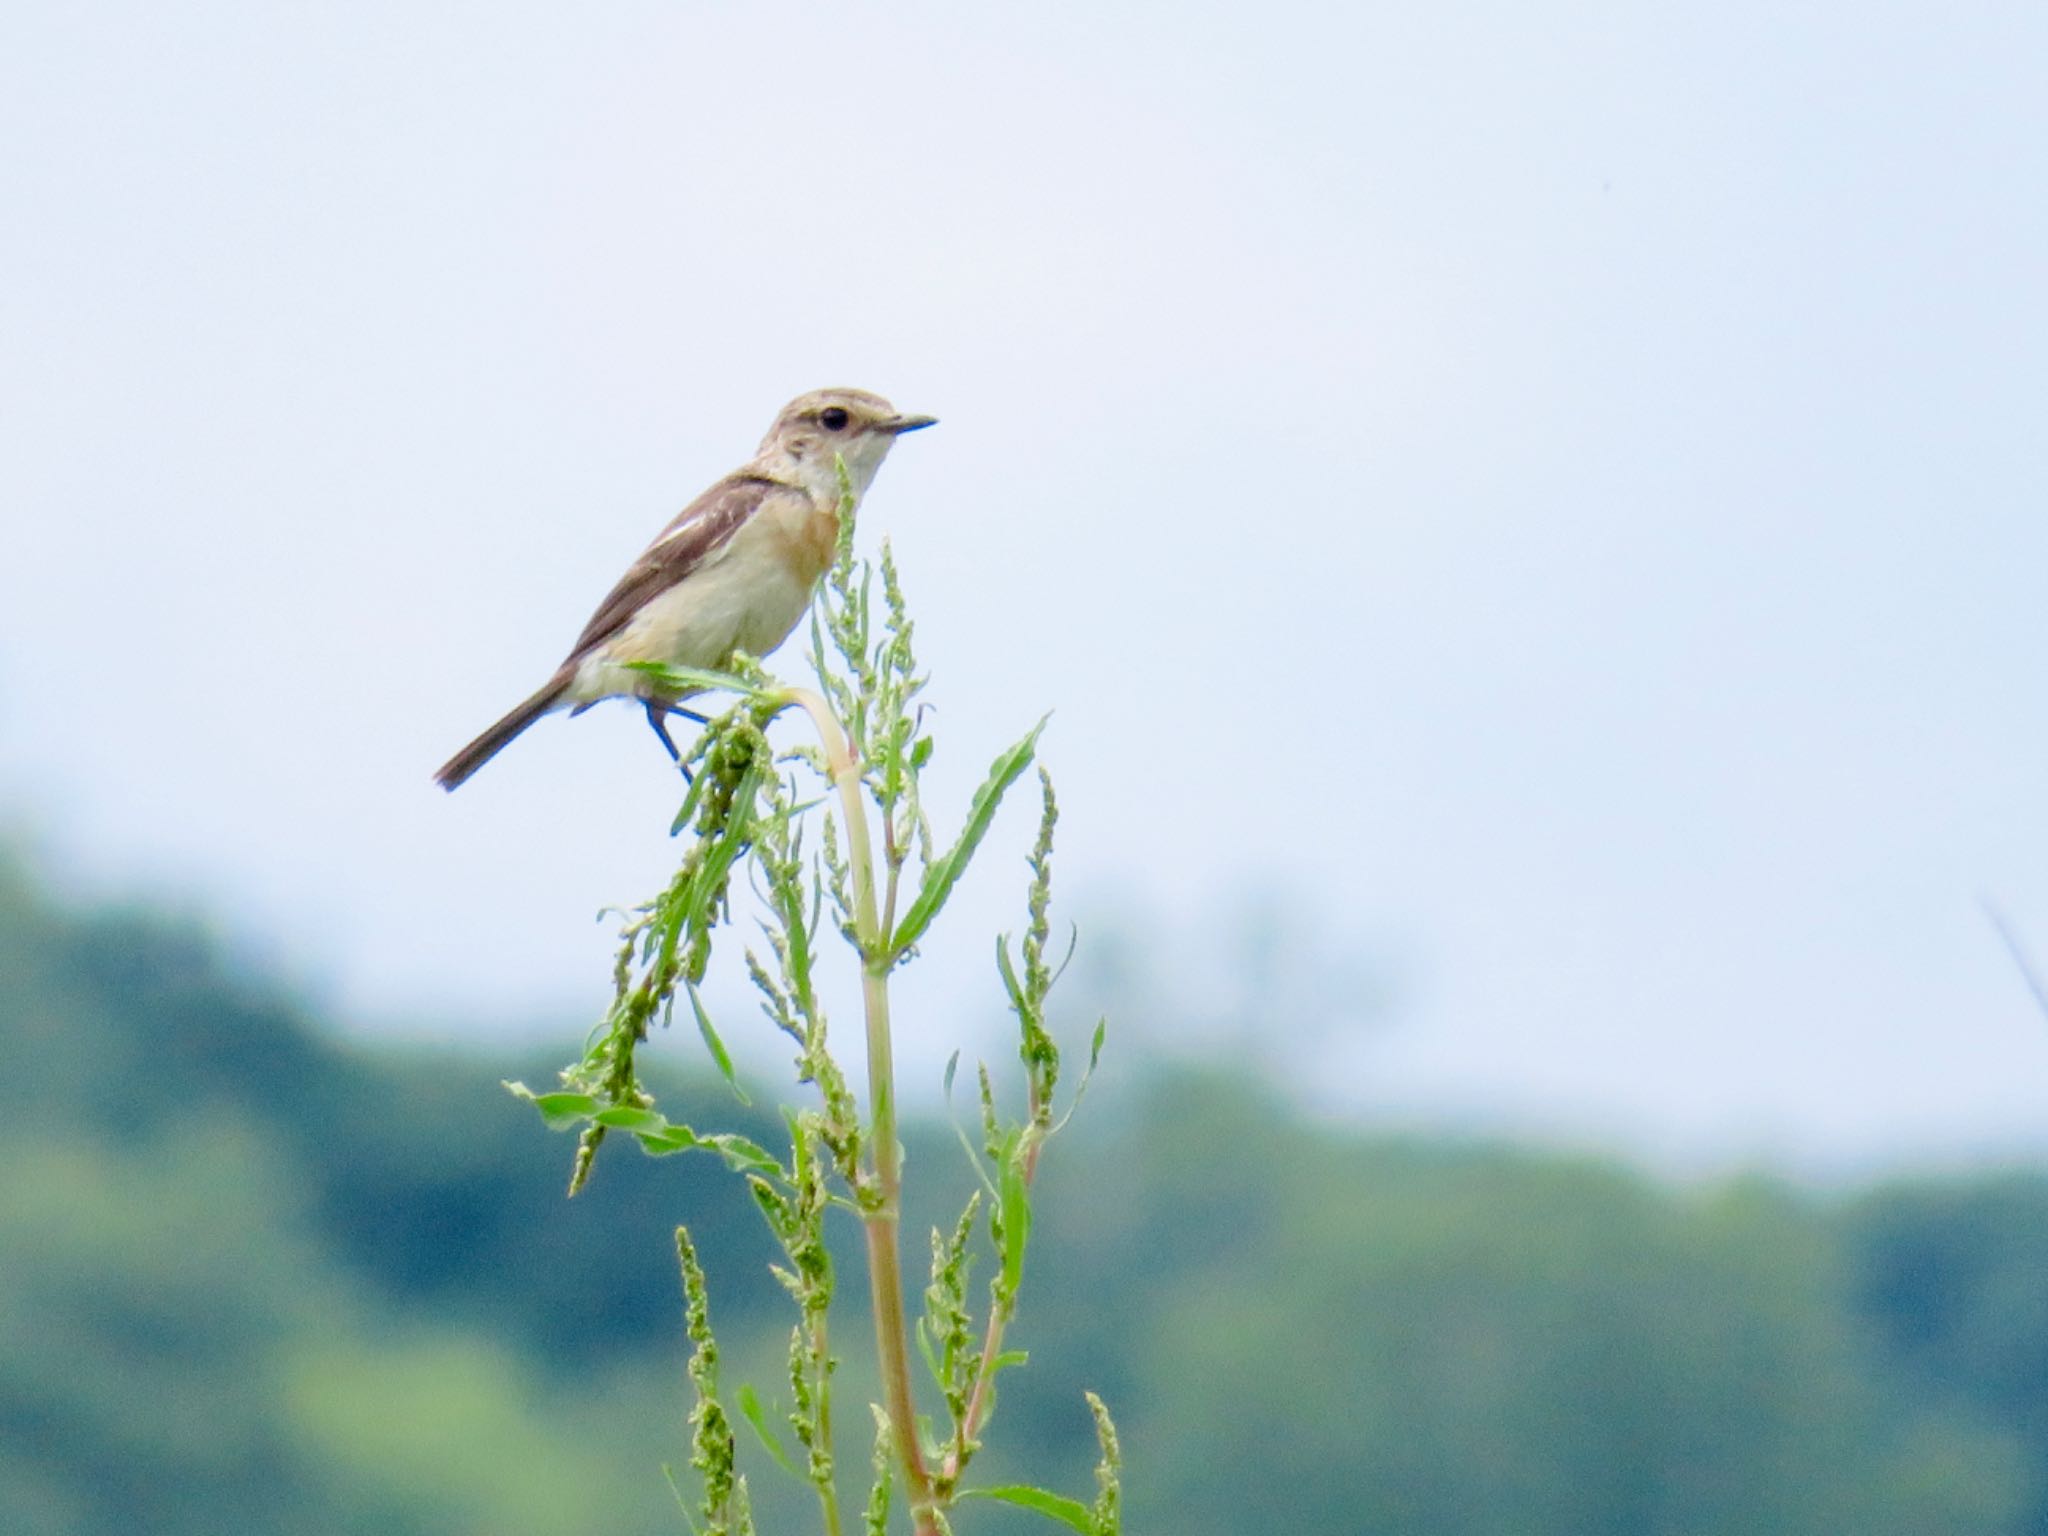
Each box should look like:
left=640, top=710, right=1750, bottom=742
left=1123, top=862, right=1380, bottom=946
left=0, top=0, right=2048, bottom=1165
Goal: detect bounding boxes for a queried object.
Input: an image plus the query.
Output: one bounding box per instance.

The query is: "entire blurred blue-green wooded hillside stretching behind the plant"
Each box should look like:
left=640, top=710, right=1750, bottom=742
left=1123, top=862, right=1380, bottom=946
left=0, top=864, right=2048, bottom=1536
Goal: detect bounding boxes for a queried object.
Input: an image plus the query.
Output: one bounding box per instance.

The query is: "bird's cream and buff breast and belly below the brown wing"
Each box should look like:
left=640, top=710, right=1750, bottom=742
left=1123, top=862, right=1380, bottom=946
left=573, top=492, right=840, bottom=700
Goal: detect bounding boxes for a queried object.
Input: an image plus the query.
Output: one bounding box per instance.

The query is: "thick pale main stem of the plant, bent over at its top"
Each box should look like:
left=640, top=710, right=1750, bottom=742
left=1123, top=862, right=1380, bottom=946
left=786, top=688, right=938, bottom=1536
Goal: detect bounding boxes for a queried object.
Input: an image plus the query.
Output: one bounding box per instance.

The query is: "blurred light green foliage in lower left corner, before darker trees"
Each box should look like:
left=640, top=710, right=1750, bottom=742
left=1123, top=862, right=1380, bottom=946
left=0, top=1112, right=679, bottom=1536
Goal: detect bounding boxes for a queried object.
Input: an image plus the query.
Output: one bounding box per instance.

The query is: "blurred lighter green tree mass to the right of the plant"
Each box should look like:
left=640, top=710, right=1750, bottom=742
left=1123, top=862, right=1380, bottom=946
left=991, top=1079, right=2028, bottom=1536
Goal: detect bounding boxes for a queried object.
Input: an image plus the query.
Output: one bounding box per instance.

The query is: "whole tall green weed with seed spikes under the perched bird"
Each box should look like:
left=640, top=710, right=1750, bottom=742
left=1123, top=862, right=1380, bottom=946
left=508, top=467, right=1114, bottom=1536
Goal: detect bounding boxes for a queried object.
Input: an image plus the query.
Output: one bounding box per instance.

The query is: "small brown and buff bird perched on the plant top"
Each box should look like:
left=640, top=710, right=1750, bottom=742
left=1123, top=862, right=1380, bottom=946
left=434, top=389, right=934, bottom=788
